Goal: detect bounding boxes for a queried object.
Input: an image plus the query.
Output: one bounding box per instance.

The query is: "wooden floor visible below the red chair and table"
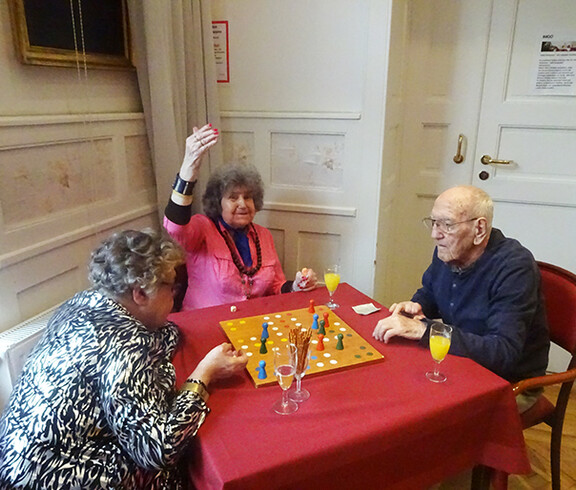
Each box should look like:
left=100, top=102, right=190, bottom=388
left=430, top=386, right=576, bottom=490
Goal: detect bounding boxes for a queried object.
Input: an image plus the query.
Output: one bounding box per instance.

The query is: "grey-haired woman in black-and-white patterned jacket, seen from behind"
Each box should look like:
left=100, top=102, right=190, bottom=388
left=0, top=231, right=247, bottom=490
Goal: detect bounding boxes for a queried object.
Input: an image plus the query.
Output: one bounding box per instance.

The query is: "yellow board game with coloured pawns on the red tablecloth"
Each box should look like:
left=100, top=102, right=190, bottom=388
left=220, top=305, right=384, bottom=387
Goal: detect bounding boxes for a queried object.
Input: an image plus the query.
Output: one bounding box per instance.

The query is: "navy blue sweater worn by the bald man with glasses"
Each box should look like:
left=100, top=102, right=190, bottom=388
left=412, top=229, right=550, bottom=382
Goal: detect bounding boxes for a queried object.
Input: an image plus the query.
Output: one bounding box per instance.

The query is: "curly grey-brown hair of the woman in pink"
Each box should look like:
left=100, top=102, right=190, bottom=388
left=202, top=163, right=264, bottom=220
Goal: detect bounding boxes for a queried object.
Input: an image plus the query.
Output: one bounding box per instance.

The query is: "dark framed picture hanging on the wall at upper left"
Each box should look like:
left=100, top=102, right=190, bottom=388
left=8, top=0, right=133, bottom=68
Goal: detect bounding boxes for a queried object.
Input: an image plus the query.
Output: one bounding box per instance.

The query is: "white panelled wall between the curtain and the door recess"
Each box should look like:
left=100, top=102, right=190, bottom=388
left=212, top=0, right=393, bottom=295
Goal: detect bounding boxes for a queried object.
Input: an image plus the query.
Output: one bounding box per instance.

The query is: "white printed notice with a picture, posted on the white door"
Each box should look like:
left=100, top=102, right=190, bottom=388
left=534, top=33, right=576, bottom=95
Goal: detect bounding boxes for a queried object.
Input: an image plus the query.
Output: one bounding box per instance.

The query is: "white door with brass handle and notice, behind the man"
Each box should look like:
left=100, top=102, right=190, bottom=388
left=473, top=0, right=576, bottom=271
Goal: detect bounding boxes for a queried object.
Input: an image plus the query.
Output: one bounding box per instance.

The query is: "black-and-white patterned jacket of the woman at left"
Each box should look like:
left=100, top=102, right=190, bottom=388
left=0, top=290, right=208, bottom=490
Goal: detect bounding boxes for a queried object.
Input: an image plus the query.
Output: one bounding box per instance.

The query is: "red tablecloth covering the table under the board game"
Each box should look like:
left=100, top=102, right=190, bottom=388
left=170, top=284, right=530, bottom=490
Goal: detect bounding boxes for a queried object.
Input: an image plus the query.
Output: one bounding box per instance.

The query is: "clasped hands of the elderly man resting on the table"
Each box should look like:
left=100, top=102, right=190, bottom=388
left=372, top=301, right=426, bottom=343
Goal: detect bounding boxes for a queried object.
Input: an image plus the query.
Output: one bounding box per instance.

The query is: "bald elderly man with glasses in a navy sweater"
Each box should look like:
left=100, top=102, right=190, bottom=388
left=373, top=186, right=550, bottom=411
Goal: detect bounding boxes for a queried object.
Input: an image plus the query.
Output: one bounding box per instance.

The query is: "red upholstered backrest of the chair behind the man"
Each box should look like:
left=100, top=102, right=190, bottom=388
left=538, top=262, right=576, bottom=368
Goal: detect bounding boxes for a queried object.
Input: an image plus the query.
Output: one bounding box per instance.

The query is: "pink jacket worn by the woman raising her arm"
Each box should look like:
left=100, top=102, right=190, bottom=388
left=164, top=214, right=286, bottom=310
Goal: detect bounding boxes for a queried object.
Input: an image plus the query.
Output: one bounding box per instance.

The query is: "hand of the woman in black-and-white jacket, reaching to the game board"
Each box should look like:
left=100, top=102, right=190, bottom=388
left=189, top=342, right=248, bottom=385
